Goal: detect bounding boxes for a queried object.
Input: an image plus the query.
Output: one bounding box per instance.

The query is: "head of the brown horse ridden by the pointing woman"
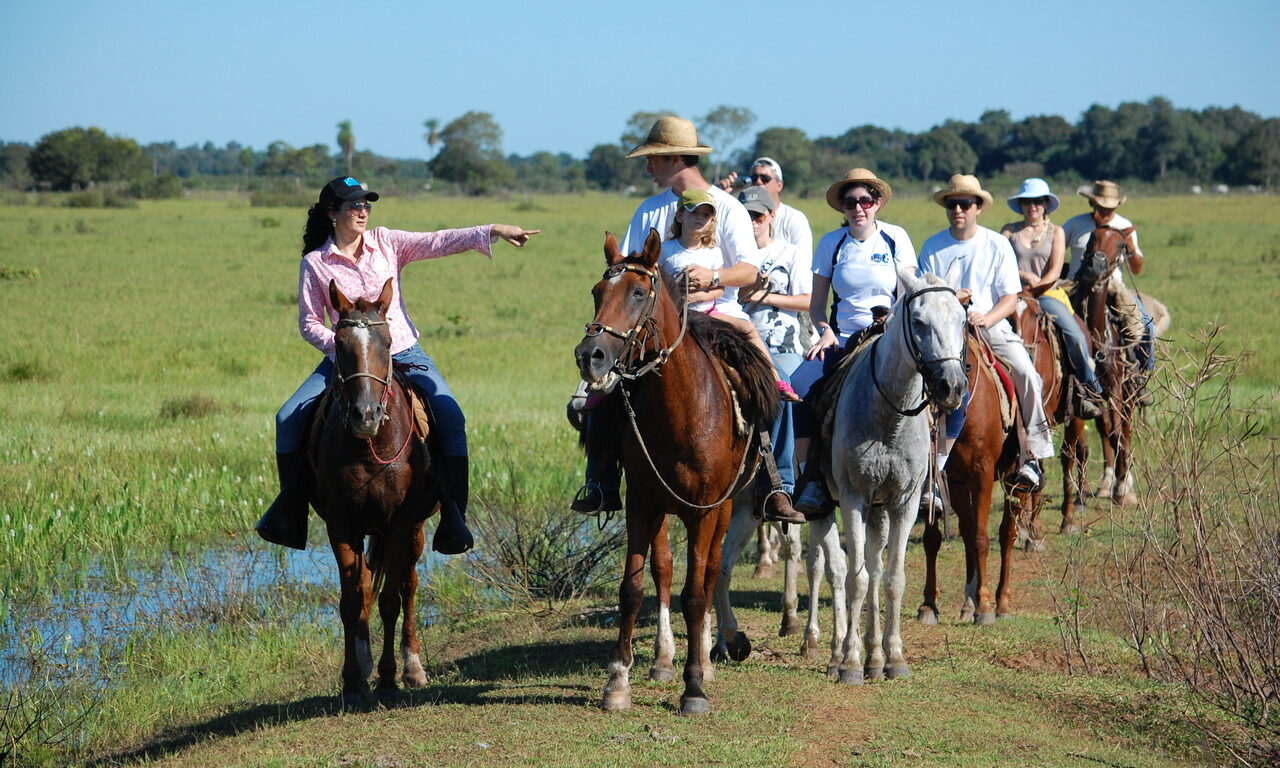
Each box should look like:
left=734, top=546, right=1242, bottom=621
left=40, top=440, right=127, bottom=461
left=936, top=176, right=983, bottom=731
left=329, top=278, right=394, bottom=439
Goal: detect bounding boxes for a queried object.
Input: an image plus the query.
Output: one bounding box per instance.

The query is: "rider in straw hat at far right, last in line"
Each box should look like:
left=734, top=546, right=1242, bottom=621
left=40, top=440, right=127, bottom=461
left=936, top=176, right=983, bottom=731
left=1062, top=180, right=1156, bottom=406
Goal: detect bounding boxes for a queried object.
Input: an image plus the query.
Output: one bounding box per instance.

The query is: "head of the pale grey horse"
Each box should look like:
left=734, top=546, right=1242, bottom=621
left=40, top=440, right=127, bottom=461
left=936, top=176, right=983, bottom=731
left=897, top=269, right=969, bottom=411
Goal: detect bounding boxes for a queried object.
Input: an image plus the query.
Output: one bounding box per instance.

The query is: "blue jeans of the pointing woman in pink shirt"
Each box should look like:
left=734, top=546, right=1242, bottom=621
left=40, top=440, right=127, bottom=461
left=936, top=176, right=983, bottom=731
left=275, top=344, right=467, bottom=456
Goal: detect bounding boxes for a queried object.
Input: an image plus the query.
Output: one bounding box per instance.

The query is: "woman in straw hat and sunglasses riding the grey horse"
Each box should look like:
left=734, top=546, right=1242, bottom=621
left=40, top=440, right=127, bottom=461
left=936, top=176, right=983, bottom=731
left=791, top=168, right=915, bottom=517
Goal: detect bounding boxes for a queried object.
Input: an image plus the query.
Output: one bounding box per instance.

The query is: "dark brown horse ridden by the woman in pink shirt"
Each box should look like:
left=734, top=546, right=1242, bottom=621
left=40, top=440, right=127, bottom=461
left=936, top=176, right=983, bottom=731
left=308, top=280, right=436, bottom=704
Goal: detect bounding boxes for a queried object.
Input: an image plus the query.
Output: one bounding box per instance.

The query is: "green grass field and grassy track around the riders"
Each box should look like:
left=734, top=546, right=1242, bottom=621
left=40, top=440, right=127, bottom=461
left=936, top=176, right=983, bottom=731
left=0, top=191, right=1280, bottom=765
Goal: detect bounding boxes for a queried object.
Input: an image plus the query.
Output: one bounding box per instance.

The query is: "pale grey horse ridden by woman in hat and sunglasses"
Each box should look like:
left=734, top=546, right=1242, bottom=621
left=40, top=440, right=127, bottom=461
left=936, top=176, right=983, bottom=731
left=809, top=270, right=968, bottom=685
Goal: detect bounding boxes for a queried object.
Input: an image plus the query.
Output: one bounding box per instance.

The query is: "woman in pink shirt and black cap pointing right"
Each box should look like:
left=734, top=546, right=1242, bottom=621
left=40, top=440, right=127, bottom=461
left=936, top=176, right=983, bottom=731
left=256, top=177, right=539, bottom=554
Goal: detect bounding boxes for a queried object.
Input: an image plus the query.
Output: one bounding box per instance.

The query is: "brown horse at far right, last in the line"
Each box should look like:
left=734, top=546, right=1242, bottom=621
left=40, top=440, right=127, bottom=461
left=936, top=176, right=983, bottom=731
left=1071, top=227, right=1140, bottom=504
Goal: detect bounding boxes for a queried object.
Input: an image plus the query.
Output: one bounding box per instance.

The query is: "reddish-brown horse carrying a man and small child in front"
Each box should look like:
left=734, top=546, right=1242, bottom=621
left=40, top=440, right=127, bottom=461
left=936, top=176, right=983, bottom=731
left=575, top=230, right=777, bottom=714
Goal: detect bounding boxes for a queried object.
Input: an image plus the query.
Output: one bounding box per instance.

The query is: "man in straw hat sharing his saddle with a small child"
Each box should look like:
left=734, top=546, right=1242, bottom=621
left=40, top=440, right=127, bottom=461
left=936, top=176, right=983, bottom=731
left=571, top=115, right=804, bottom=522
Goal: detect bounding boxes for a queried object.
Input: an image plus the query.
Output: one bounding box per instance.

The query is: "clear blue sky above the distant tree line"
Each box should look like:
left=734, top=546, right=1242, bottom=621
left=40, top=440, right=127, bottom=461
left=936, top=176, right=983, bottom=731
left=0, top=0, right=1280, bottom=157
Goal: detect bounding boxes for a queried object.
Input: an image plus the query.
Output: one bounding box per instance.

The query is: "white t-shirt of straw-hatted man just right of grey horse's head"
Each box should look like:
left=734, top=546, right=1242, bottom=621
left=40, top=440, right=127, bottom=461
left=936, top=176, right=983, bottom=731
left=919, top=227, right=1023, bottom=314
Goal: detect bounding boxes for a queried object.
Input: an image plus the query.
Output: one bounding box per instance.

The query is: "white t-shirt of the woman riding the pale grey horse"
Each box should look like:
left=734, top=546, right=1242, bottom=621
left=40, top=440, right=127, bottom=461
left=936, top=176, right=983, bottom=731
left=813, top=221, right=915, bottom=339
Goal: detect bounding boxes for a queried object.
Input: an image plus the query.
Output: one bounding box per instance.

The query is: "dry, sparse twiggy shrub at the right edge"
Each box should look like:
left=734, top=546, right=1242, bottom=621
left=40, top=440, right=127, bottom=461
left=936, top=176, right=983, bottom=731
left=1096, top=328, right=1280, bottom=765
